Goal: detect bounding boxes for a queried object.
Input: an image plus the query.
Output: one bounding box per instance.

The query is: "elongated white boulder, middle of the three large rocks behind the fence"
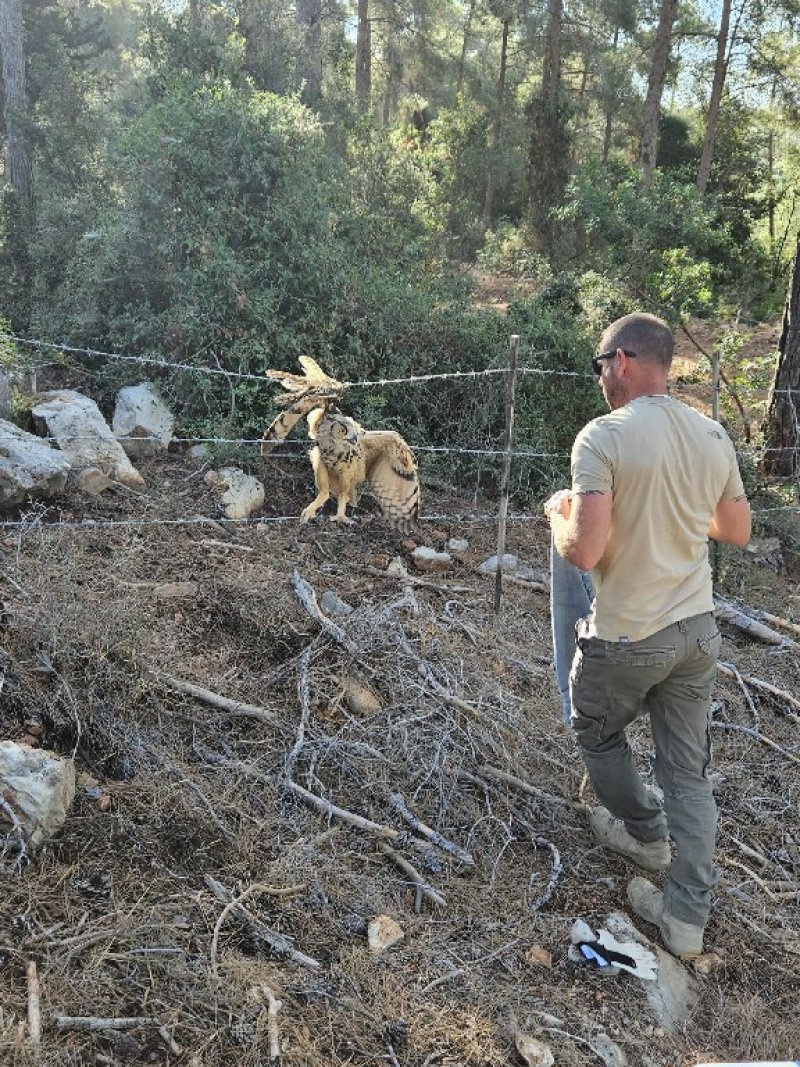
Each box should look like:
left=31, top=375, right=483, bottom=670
left=31, top=389, right=144, bottom=489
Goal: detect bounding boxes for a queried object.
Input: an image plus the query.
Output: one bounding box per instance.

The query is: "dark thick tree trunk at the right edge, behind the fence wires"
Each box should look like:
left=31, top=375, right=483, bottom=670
left=764, top=234, right=800, bottom=477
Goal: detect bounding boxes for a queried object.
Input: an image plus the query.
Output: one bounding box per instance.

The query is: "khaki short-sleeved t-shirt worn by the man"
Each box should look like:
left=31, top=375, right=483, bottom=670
left=572, top=396, right=745, bottom=641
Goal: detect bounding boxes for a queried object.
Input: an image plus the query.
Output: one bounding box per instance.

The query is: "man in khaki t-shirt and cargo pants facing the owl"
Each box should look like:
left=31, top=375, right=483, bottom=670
left=545, top=314, right=750, bottom=958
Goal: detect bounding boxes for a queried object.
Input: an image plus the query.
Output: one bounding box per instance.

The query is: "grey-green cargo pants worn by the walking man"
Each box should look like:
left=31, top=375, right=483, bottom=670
left=570, top=612, right=721, bottom=926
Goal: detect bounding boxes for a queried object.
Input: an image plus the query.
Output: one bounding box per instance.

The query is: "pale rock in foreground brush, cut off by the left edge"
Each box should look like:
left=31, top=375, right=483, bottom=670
left=0, top=740, right=75, bottom=846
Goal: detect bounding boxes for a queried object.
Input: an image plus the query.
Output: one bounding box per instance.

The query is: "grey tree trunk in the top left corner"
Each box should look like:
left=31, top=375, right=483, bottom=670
left=0, top=0, right=33, bottom=211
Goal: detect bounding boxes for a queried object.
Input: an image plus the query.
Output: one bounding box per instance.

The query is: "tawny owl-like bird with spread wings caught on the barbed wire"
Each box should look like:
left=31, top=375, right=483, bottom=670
left=261, top=356, right=419, bottom=534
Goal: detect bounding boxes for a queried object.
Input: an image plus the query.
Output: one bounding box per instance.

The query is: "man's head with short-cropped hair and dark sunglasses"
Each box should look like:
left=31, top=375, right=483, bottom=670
left=594, top=313, right=674, bottom=410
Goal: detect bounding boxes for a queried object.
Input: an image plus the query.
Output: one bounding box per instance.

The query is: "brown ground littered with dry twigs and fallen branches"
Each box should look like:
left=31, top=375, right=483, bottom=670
left=0, top=426, right=800, bottom=1067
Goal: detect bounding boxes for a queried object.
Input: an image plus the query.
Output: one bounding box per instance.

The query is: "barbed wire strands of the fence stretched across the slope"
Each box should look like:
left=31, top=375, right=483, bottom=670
left=0, top=322, right=800, bottom=529
